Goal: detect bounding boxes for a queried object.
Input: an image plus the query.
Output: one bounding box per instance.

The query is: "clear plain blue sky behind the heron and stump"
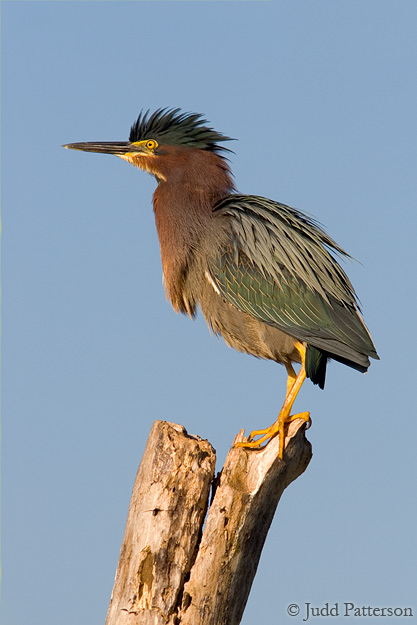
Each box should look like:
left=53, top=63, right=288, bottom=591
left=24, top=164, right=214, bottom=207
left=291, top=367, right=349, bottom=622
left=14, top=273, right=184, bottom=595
left=0, top=0, right=417, bottom=625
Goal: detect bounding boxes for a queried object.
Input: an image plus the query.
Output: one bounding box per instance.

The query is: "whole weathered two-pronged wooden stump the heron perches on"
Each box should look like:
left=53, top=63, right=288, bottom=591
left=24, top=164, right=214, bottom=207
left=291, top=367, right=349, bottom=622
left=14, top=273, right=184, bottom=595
left=106, top=419, right=312, bottom=625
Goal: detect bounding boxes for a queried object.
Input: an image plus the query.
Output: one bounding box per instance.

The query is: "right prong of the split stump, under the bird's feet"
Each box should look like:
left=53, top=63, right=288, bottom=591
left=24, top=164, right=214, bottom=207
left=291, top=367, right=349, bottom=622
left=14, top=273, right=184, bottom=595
left=180, top=419, right=312, bottom=625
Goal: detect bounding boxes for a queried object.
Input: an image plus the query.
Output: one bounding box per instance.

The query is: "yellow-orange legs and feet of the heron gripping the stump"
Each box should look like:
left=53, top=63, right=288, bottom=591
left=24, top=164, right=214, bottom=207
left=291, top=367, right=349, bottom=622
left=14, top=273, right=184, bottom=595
left=236, top=342, right=310, bottom=458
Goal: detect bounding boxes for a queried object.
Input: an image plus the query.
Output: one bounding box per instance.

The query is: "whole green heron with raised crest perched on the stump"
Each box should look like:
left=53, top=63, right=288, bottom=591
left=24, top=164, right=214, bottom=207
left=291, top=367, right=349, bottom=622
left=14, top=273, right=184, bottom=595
left=64, top=109, right=378, bottom=458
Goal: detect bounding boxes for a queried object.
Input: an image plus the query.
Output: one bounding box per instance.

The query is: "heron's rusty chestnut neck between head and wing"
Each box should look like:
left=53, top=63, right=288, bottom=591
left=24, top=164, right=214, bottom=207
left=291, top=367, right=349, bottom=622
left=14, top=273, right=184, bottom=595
left=153, top=150, right=235, bottom=315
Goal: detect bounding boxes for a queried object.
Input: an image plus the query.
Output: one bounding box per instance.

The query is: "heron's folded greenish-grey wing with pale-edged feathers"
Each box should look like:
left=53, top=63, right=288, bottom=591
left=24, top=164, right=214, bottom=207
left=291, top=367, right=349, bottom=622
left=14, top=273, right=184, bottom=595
left=209, top=195, right=376, bottom=363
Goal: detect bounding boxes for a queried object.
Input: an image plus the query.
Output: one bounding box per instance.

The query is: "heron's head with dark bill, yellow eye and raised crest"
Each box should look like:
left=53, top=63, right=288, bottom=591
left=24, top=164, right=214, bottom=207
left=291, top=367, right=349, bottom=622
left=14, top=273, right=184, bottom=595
left=63, top=108, right=232, bottom=180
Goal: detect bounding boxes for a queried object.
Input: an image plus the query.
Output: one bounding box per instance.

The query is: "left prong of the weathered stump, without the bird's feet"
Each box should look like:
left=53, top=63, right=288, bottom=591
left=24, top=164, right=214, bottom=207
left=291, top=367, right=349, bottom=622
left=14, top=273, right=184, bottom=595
left=106, top=421, right=215, bottom=625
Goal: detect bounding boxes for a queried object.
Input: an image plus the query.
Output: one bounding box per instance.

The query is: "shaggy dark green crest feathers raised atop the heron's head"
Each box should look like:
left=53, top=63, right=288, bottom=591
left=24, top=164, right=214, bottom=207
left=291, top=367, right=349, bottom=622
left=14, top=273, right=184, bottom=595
left=129, top=108, right=234, bottom=152
